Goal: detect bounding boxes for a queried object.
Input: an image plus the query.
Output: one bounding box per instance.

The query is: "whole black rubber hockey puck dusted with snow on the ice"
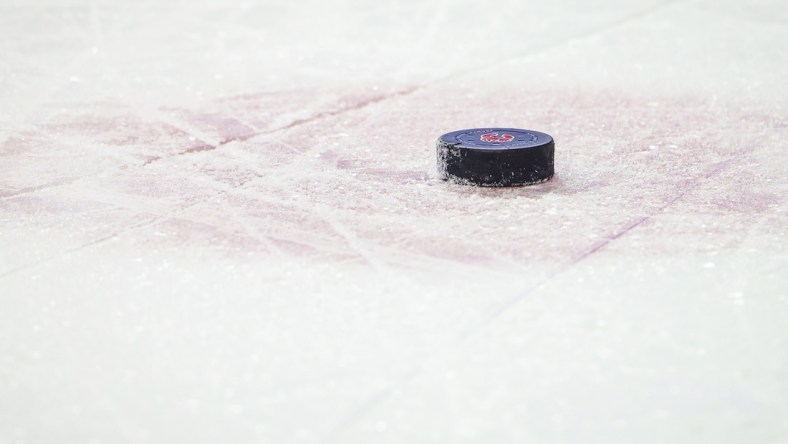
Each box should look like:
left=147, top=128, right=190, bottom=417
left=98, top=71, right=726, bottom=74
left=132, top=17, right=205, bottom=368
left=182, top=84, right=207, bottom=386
left=437, top=128, right=555, bottom=187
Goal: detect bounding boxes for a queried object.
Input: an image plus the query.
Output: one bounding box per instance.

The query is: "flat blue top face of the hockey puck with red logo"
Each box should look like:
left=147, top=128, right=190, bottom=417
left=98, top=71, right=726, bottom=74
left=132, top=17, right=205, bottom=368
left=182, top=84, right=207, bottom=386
left=440, top=128, right=553, bottom=150
